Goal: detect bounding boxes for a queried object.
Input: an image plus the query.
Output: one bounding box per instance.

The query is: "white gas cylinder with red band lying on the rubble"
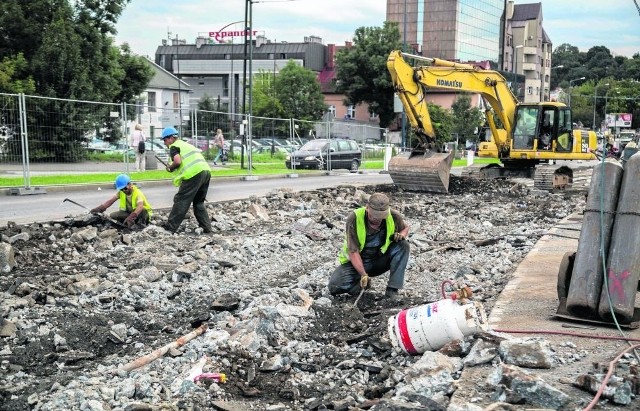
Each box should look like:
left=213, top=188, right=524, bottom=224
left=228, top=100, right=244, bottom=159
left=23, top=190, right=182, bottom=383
left=387, top=299, right=488, bottom=355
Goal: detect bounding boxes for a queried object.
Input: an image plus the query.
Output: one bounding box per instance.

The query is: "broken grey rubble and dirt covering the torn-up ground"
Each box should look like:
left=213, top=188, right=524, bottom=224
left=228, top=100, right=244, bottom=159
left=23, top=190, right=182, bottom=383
left=0, top=178, right=628, bottom=411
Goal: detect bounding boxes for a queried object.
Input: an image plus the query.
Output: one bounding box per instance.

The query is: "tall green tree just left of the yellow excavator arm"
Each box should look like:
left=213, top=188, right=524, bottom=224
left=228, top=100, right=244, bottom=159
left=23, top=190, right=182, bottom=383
left=336, top=21, right=402, bottom=127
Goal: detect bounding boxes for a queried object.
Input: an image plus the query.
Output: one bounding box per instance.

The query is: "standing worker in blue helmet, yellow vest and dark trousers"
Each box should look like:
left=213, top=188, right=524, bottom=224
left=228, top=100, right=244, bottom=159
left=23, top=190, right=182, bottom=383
left=162, top=127, right=212, bottom=233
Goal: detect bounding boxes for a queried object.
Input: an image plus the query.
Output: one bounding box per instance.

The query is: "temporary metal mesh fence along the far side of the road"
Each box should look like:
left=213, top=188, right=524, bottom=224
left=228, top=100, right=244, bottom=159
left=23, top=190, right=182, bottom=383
left=0, top=93, right=387, bottom=188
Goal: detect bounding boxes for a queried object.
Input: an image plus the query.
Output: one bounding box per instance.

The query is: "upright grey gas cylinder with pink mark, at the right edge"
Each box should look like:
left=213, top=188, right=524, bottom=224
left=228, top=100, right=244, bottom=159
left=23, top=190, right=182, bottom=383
left=598, top=155, right=640, bottom=323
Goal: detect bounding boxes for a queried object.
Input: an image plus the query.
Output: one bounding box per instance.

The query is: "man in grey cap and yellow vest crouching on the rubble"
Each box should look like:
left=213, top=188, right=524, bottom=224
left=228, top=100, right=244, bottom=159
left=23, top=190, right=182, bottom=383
left=328, top=193, right=409, bottom=301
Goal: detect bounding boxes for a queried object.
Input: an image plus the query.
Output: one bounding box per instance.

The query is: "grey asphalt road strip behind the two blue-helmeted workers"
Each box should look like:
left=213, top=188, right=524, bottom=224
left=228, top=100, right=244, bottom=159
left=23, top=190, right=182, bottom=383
left=0, top=172, right=392, bottom=226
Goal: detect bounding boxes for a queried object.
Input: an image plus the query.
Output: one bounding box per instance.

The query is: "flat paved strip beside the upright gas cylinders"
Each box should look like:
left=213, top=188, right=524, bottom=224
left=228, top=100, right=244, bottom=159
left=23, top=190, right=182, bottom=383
left=451, top=213, right=640, bottom=409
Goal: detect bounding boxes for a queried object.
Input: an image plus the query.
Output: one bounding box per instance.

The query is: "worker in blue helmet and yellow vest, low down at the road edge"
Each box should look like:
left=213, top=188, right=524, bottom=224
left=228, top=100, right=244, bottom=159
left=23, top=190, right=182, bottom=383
left=91, top=174, right=153, bottom=227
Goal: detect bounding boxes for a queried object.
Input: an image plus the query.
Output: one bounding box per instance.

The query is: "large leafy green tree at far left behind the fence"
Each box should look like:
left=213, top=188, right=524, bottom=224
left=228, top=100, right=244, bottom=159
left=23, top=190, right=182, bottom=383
left=0, top=0, right=153, bottom=161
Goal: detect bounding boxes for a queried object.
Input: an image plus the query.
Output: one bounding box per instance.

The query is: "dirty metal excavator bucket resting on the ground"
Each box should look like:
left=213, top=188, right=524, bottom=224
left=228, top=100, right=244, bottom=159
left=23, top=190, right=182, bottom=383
left=389, top=151, right=453, bottom=193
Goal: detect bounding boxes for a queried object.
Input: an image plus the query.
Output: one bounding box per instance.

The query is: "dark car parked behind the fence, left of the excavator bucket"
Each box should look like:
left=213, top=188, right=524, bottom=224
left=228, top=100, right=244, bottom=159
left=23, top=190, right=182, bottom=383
left=285, top=139, right=362, bottom=172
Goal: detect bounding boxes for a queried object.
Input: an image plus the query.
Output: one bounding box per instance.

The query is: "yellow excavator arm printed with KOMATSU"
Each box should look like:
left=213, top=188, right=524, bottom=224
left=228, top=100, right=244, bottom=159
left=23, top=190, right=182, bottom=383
left=387, top=50, right=518, bottom=150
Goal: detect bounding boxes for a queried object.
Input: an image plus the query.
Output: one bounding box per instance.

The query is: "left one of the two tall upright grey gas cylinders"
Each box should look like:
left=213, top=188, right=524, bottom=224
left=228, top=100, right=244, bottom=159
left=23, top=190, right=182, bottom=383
left=567, top=159, right=623, bottom=319
